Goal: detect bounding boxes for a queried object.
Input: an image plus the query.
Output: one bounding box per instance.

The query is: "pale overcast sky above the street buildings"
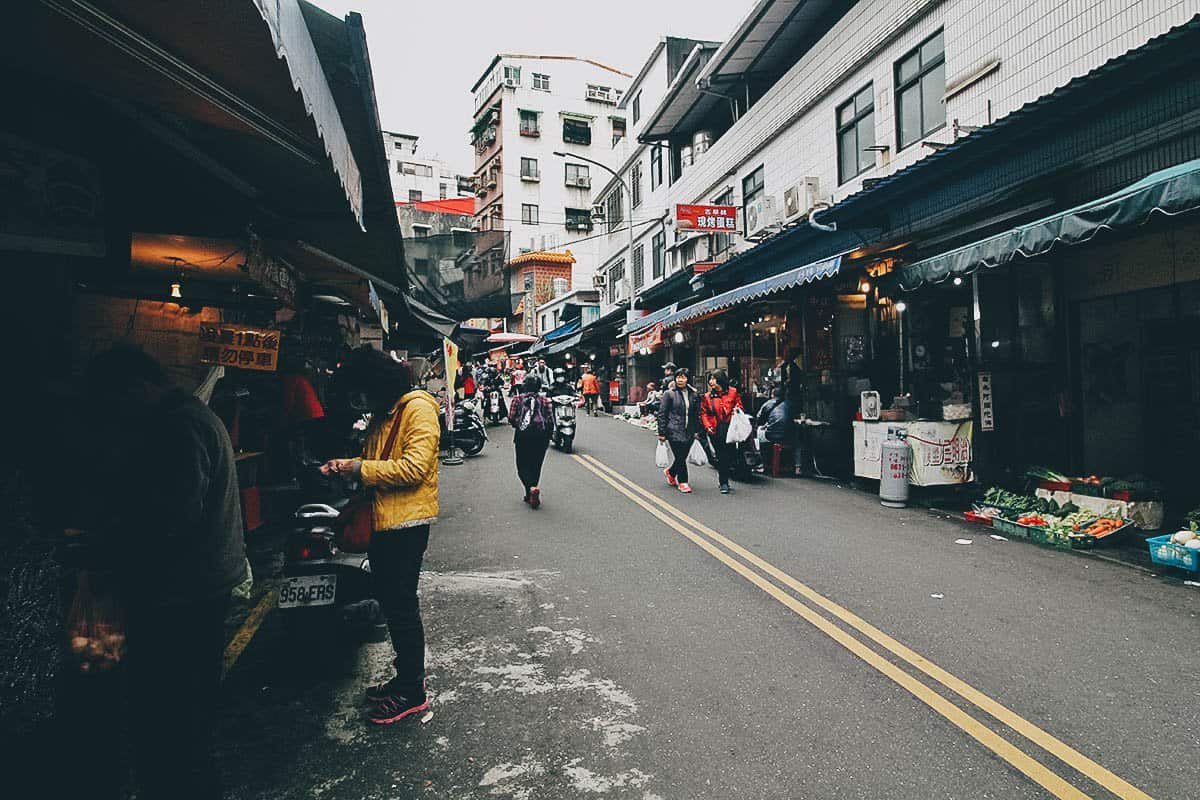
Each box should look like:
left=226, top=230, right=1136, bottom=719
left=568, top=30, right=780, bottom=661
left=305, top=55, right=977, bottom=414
left=314, top=0, right=752, bottom=174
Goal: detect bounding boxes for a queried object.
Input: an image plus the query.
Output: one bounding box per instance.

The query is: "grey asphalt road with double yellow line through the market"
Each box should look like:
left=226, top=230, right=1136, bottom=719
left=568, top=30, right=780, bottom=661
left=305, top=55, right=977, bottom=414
left=222, top=419, right=1200, bottom=800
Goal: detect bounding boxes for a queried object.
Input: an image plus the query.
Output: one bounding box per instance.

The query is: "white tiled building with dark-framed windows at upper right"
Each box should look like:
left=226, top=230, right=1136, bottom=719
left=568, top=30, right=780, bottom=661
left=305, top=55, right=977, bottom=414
left=602, top=0, right=1198, bottom=307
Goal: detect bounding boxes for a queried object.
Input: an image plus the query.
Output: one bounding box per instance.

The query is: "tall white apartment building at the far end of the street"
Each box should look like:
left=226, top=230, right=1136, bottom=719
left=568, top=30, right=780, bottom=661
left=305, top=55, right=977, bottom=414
left=470, top=53, right=631, bottom=294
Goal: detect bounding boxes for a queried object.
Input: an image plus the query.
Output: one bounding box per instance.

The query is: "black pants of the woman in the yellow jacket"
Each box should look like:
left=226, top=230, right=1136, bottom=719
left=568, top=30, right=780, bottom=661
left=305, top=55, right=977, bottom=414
left=368, top=525, right=430, bottom=698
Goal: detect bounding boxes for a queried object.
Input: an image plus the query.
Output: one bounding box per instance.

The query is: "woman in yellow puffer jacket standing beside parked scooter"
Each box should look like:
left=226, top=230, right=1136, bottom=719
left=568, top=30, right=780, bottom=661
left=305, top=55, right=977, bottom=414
left=320, top=357, right=440, bottom=724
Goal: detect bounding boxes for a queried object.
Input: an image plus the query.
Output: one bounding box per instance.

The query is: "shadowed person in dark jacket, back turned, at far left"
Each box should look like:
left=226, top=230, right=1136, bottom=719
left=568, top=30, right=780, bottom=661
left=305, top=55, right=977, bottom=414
left=86, top=345, right=247, bottom=800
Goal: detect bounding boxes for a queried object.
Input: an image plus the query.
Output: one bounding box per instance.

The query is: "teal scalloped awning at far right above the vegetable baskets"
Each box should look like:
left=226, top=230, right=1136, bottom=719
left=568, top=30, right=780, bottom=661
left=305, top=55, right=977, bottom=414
left=896, top=154, right=1200, bottom=291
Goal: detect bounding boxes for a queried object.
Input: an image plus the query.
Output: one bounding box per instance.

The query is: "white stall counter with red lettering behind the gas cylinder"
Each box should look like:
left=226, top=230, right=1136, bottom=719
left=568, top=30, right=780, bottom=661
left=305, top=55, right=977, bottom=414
left=854, top=420, right=974, bottom=486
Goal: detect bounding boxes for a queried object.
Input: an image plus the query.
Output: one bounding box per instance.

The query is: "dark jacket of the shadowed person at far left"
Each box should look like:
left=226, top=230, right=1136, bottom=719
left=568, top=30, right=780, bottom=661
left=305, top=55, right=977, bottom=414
left=122, top=392, right=246, bottom=603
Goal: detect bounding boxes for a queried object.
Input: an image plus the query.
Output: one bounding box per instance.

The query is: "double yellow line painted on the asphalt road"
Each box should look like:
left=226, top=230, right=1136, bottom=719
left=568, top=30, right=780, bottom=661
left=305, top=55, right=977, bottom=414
left=574, top=455, right=1150, bottom=800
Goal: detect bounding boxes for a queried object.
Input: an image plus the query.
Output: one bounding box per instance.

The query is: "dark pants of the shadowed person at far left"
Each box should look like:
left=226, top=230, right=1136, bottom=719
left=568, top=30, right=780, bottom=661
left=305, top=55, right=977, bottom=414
left=127, top=596, right=229, bottom=800
